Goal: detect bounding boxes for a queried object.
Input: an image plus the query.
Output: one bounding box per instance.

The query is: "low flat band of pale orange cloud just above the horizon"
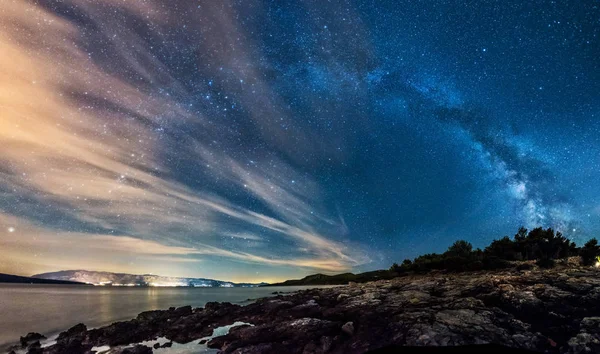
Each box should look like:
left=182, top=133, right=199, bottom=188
left=0, top=215, right=356, bottom=273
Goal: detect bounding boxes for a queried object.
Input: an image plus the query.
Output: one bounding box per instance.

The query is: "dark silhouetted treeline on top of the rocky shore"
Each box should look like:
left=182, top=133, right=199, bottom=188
left=390, top=227, right=600, bottom=273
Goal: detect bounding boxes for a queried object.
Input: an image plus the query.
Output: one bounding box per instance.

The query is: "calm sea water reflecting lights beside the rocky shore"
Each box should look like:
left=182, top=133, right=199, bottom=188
left=0, top=284, right=332, bottom=351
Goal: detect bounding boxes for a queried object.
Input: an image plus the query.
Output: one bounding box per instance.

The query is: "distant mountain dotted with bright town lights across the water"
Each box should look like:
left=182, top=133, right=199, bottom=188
left=33, top=270, right=267, bottom=288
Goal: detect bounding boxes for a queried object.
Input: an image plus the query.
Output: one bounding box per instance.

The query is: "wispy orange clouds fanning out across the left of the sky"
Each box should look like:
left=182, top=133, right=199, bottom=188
left=0, top=0, right=368, bottom=280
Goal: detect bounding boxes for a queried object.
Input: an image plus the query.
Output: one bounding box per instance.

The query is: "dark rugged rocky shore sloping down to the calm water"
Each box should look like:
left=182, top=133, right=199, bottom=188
left=10, top=265, right=600, bottom=354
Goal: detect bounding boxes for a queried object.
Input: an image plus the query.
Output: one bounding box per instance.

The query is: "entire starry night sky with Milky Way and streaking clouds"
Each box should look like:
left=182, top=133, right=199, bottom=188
left=0, top=0, right=600, bottom=281
